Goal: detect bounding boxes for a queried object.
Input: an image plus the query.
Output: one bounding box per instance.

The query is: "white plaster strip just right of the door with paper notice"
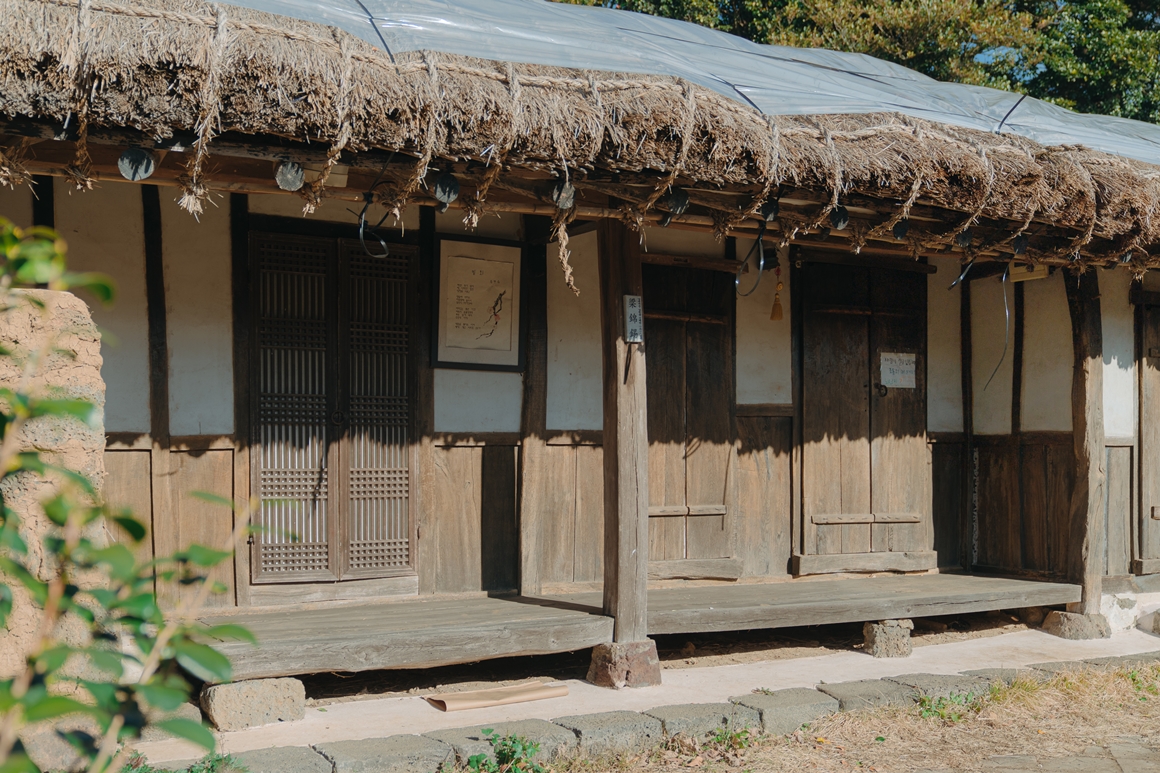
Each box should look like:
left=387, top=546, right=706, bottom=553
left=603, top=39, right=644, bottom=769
left=927, top=257, right=963, bottom=432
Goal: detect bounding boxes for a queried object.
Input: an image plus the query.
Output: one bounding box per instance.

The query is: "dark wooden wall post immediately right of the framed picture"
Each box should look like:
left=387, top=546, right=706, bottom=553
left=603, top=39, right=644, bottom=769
left=520, top=215, right=557, bottom=595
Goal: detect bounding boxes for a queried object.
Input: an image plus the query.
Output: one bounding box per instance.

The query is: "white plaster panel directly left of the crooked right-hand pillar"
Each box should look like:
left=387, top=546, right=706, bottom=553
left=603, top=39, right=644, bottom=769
left=1008, top=272, right=1071, bottom=432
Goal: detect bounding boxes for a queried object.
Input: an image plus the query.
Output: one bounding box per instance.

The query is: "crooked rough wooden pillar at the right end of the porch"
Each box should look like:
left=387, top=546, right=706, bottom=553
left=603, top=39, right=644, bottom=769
left=1064, top=270, right=1107, bottom=614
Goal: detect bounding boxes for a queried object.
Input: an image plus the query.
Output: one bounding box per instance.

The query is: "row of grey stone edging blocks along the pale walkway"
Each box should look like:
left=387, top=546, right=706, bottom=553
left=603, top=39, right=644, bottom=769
left=154, top=651, right=1160, bottom=773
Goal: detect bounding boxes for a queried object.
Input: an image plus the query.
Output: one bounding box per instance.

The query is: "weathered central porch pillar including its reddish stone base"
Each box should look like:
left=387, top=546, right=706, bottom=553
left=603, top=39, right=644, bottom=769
left=588, top=221, right=660, bottom=687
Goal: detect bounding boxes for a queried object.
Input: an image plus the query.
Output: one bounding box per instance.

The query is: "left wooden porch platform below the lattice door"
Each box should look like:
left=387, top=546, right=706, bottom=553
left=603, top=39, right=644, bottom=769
left=201, top=597, right=612, bottom=679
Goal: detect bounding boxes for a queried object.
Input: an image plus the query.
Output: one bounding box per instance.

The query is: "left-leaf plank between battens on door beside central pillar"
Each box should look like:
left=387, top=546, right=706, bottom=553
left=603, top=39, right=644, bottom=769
left=645, top=317, right=687, bottom=508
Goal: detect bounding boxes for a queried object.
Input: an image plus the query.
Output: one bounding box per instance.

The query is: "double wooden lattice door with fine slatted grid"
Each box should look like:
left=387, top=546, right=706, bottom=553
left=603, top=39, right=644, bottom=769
left=251, top=233, right=413, bottom=583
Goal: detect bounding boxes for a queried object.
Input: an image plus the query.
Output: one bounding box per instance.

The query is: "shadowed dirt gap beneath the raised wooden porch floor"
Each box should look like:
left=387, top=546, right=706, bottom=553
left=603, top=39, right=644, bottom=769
left=302, top=612, right=1027, bottom=706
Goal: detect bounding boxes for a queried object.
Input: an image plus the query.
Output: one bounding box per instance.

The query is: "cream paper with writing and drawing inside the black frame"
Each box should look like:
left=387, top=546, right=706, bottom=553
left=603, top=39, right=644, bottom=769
left=443, top=255, right=515, bottom=352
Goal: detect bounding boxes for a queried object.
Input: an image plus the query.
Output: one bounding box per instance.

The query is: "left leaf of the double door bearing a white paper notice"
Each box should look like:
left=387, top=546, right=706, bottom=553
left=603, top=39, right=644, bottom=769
left=802, top=311, right=871, bottom=555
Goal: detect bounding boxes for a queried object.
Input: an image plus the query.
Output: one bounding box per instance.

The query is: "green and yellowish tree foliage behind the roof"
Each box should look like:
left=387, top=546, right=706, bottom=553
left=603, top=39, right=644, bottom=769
left=563, top=0, right=1160, bottom=123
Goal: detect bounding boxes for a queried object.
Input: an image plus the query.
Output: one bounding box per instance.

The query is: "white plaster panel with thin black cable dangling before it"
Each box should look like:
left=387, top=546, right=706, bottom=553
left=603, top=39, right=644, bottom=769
left=971, top=276, right=1015, bottom=435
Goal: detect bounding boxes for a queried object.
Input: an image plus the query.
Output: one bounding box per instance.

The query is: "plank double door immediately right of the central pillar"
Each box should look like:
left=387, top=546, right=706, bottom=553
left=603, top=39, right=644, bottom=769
left=644, top=266, right=734, bottom=561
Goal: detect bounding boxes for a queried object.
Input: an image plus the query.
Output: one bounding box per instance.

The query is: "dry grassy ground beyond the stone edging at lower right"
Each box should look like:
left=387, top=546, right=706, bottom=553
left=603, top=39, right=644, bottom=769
left=577, top=665, right=1160, bottom=773
